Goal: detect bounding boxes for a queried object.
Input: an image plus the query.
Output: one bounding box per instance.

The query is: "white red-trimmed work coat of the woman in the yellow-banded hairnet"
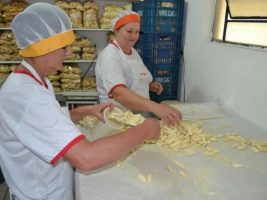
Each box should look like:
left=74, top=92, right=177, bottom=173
left=0, top=61, right=84, bottom=200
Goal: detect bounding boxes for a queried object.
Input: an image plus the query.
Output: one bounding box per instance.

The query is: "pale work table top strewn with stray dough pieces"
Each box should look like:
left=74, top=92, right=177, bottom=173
left=75, top=102, right=267, bottom=200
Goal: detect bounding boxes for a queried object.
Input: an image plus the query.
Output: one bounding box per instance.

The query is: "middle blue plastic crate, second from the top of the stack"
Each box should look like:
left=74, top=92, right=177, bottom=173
left=135, top=33, right=181, bottom=66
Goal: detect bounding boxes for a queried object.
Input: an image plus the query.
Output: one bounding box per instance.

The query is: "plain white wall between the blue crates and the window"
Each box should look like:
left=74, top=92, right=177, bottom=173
left=184, top=0, right=267, bottom=131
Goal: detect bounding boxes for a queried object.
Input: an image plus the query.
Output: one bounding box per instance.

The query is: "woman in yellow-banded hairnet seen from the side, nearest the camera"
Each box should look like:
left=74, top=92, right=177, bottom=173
left=0, top=3, right=160, bottom=200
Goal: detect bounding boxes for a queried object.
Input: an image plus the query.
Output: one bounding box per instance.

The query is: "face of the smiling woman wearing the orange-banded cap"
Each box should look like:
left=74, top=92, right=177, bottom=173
left=115, top=22, right=140, bottom=48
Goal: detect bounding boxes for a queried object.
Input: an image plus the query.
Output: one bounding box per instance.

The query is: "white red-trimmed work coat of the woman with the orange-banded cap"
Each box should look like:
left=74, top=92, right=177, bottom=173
left=95, top=40, right=152, bottom=105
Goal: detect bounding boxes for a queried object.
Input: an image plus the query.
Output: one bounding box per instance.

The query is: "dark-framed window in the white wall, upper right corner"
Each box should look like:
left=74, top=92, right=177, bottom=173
left=212, top=0, right=267, bottom=48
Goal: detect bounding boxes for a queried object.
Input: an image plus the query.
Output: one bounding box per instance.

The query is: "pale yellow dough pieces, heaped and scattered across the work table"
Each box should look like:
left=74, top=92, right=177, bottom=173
left=82, top=110, right=267, bottom=187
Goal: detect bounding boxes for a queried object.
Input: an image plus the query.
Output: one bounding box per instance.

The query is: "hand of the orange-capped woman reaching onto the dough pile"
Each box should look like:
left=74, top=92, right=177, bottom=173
left=153, top=104, right=182, bottom=125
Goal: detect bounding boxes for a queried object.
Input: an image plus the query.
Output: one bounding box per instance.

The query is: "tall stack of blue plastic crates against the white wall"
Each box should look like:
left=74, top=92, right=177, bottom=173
left=133, top=0, right=184, bottom=102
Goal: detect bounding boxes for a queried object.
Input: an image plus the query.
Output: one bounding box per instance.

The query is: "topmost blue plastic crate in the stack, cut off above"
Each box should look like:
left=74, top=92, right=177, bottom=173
left=133, top=0, right=184, bottom=33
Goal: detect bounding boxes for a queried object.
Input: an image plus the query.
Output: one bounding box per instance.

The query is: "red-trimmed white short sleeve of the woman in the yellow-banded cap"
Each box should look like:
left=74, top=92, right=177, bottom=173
left=16, top=95, right=83, bottom=163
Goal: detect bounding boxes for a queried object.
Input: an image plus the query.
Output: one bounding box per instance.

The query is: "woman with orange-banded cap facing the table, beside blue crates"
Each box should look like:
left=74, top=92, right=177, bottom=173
left=96, top=10, right=181, bottom=124
